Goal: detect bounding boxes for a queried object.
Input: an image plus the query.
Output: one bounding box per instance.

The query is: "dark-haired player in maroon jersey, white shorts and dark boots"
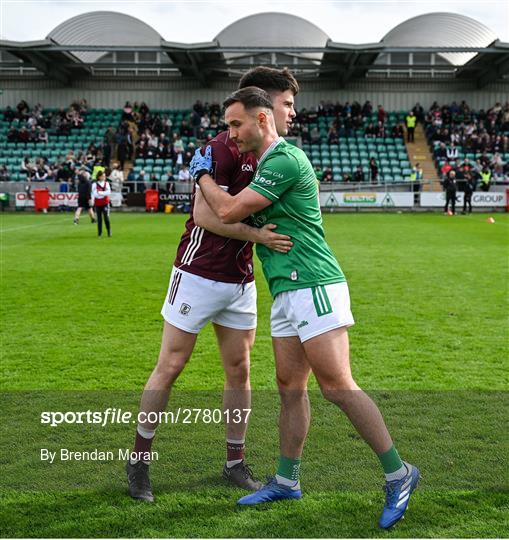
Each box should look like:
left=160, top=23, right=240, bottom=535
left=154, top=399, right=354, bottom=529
left=126, top=67, right=299, bottom=502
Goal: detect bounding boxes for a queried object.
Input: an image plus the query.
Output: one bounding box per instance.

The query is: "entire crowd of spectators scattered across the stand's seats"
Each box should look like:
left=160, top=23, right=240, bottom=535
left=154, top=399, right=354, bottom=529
left=5, top=99, right=509, bottom=190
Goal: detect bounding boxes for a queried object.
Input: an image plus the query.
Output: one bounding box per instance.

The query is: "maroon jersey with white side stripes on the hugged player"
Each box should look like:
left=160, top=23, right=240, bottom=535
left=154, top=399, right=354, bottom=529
left=174, top=131, right=257, bottom=283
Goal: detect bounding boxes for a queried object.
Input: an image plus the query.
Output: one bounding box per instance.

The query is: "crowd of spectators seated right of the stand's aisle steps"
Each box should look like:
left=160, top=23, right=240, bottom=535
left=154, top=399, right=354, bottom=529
left=425, top=101, right=509, bottom=190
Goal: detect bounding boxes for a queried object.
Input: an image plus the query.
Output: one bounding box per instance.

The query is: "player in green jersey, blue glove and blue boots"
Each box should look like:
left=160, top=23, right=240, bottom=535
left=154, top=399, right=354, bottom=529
left=191, top=87, right=419, bottom=528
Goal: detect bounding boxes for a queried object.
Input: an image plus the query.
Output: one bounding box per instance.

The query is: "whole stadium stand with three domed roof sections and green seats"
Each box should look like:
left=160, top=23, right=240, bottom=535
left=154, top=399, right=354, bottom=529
left=0, top=11, right=509, bottom=209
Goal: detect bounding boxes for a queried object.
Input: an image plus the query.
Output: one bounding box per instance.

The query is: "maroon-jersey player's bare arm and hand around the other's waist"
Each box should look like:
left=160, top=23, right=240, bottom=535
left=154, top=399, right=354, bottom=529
left=193, top=188, right=293, bottom=253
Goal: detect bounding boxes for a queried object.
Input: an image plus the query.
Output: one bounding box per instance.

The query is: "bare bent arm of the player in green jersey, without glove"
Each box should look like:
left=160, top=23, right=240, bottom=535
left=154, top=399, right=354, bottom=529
left=199, top=174, right=272, bottom=223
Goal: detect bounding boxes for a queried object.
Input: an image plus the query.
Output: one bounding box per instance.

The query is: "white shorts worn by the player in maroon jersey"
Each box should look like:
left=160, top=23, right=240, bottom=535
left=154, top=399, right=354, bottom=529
left=161, top=267, right=256, bottom=334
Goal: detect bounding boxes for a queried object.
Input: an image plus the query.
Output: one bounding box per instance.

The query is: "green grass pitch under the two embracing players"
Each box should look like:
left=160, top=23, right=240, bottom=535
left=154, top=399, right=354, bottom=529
left=0, top=214, right=509, bottom=537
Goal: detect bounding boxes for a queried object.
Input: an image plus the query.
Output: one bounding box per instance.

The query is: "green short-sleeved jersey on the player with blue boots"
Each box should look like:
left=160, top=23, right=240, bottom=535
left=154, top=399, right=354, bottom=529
left=249, top=137, right=346, bottom=297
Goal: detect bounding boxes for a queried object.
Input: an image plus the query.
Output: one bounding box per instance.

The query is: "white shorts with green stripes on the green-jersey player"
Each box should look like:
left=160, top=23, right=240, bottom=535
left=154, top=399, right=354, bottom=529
left=270, top=282, right=355, bottom=342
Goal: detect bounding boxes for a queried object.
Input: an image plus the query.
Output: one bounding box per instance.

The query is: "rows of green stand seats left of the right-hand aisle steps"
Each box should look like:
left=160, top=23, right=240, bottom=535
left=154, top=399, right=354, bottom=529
left=0, top=101, right=411, bottom=189
